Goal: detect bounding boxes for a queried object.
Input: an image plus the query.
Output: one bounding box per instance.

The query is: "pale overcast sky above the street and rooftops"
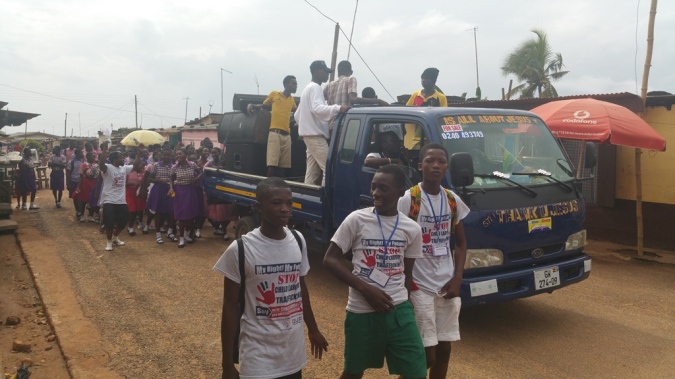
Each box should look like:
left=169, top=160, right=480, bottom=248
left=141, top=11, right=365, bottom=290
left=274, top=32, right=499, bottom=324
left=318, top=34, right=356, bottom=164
left=0, top=0, right=675, bottom=136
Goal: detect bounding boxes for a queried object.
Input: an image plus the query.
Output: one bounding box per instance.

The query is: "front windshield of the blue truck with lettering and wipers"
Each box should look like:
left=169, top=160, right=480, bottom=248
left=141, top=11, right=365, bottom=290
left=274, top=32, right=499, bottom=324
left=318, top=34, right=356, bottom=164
left=436, top=114, right=574, bottom=188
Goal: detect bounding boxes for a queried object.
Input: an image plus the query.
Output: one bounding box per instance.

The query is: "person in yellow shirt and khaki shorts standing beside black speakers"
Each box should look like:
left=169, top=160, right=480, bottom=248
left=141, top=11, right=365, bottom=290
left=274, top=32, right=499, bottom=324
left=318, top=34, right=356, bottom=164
left=246, top=75, right=298, bottom=178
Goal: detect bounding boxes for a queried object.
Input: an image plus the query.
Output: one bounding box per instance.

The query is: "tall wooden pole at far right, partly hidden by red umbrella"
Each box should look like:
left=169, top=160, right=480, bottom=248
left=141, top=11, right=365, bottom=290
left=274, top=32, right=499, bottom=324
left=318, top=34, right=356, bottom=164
left=635, top=0, right=658, bottom=257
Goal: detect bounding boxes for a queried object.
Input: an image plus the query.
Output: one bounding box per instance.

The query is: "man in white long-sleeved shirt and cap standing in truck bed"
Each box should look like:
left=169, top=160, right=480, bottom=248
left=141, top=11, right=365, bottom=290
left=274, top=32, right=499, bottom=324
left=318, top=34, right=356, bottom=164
left=294, top=61, right=350, bottom=185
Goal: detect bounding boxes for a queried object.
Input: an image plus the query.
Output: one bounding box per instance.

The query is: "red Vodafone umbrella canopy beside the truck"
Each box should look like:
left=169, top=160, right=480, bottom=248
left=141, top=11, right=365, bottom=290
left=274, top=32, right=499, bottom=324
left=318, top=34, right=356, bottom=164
left=531, top=98, right=666, bottom=151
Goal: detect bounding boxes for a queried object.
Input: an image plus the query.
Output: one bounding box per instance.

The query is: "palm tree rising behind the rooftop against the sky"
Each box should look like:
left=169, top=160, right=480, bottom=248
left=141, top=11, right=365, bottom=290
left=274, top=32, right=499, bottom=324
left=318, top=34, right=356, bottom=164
left=502, top=29, right=569, bottom=98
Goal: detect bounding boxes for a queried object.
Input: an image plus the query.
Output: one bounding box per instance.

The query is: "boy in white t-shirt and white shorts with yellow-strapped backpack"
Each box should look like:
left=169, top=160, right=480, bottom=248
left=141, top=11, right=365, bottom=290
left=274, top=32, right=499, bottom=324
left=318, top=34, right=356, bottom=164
left=398, top=143, right=469, bottom=379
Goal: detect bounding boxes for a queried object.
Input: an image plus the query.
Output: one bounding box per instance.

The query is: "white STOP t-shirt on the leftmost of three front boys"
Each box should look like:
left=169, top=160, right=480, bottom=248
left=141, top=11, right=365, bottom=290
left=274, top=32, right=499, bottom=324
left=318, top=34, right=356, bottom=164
left=213, top=228, right=309, bottom=379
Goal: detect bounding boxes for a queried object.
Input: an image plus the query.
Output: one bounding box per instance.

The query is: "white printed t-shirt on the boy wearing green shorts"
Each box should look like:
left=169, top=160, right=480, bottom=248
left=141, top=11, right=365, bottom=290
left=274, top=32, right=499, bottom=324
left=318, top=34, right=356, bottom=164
left=331, top=207, right=422, bottom=313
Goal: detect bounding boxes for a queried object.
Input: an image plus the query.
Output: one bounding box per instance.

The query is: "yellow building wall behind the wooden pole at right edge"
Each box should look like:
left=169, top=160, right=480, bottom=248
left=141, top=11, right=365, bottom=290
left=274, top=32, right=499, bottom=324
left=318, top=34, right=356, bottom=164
left=616, top=107, right=675, bottom=204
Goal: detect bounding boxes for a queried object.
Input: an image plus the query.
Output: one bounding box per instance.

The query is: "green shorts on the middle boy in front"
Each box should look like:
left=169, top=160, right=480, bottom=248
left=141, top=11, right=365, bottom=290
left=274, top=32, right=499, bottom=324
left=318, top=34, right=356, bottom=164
left=345, top=301, right=427, bottom=378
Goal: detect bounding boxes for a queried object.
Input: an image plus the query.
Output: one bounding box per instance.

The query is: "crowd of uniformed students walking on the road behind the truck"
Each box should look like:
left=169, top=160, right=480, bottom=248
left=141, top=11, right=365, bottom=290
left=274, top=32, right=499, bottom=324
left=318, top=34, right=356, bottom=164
left=39, top=143, right=236, bottom=251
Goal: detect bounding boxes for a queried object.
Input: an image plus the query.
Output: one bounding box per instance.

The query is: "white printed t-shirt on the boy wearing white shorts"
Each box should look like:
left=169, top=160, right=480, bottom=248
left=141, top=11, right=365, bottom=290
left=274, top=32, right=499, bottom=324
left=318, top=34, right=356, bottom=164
left=398, top=186, right=469, bottom=296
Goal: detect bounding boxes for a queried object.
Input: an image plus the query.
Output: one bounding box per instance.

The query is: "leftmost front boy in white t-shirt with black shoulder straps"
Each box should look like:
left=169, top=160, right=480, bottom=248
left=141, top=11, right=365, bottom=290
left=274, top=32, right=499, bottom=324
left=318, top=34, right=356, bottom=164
left=213, top=177, right=328, bottom=379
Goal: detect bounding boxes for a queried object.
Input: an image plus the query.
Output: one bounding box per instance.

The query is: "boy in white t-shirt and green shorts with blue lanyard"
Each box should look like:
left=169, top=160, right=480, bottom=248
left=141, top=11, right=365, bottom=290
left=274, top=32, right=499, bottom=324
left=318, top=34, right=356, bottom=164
left=323, top=164, right=427, bottom=379
